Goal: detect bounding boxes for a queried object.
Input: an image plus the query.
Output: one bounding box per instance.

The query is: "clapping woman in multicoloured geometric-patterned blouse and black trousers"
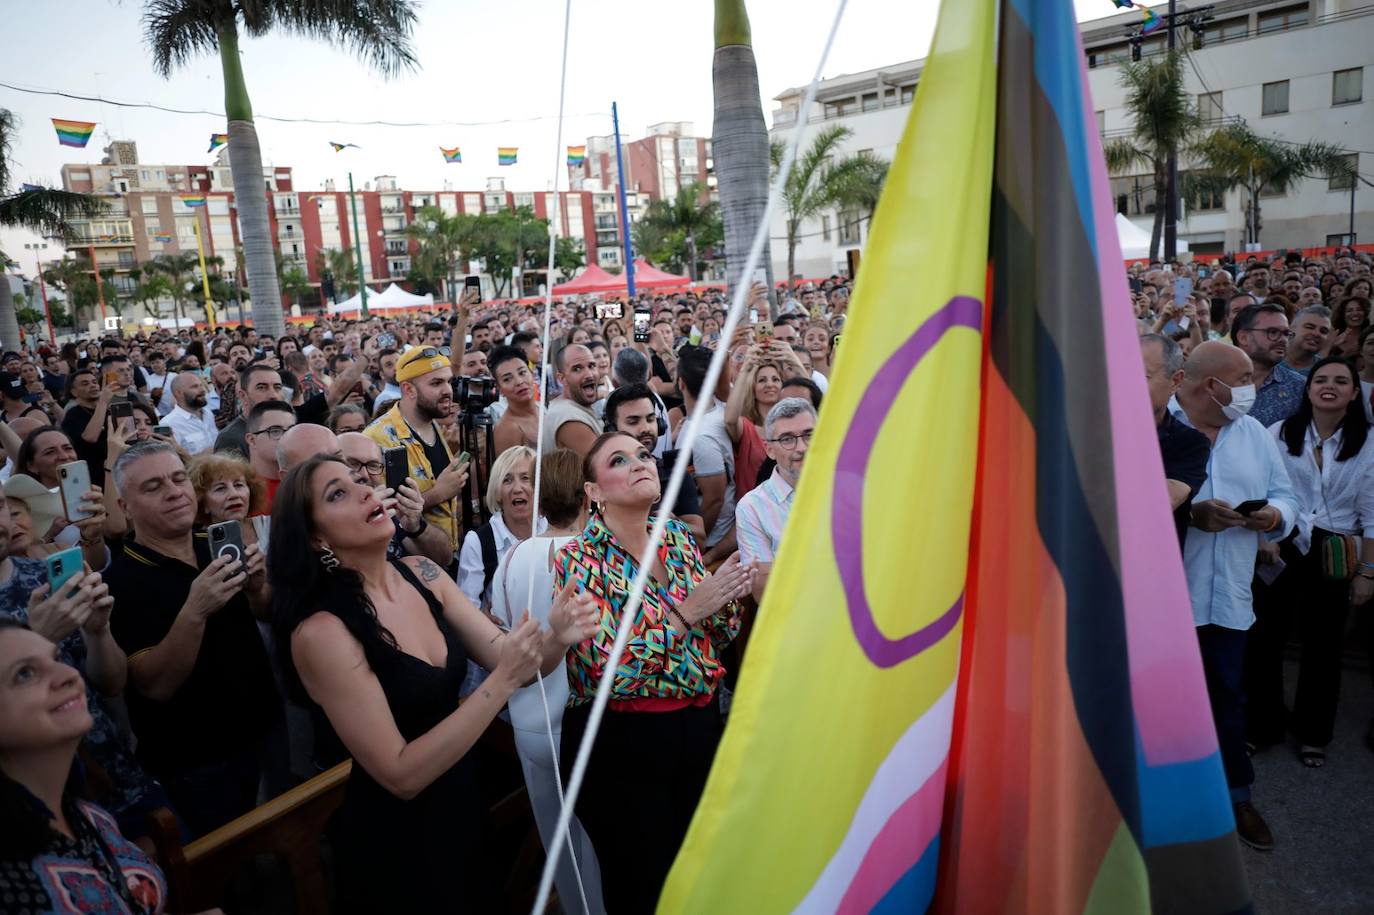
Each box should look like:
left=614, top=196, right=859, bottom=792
left=555, top=433, right=752, bottom=912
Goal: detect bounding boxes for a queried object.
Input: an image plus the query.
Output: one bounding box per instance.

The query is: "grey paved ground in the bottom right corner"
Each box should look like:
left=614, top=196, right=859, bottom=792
left=1242, top=653, right=1374, bottom=914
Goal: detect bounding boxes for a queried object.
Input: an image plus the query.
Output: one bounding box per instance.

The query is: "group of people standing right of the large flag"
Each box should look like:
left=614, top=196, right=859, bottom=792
left=1129, top=250, right=1374, bottom=850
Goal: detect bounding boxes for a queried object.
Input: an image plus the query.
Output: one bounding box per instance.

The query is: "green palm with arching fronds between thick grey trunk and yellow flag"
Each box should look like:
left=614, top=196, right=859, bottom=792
left=768, top=124, right=888, bottom=287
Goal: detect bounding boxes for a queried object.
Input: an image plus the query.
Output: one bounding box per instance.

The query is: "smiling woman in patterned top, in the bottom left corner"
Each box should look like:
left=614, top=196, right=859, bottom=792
left=0, top=618, right=166, bottom=915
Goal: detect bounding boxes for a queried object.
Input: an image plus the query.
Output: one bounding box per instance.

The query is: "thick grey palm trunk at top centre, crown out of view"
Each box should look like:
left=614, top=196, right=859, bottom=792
left=710, top=0, right=778, bottom=312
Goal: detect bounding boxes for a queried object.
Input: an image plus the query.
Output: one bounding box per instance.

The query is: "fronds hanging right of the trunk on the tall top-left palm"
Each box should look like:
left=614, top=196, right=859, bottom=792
left=247, top=0, right=419, bottom=77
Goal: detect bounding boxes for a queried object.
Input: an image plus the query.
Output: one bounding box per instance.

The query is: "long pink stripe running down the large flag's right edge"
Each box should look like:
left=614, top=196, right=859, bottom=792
left=1079, top=49, right=1216, bottom=765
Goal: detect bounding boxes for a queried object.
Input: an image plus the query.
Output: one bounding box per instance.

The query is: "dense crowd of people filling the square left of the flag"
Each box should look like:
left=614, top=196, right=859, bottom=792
left=0, top=279, right=849, bottom=912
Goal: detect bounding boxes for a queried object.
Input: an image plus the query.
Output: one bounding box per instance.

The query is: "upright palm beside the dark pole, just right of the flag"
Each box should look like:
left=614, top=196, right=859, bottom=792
left=1102, top=51, right=1202, bottom=260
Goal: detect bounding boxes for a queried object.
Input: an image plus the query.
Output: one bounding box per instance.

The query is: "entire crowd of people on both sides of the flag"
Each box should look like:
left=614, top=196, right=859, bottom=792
left=0, top=241, right=1374, bottom=912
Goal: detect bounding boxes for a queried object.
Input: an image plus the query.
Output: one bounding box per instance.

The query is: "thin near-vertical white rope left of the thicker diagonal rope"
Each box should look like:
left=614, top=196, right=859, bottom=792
left=517, top=0, right=591, bottom=915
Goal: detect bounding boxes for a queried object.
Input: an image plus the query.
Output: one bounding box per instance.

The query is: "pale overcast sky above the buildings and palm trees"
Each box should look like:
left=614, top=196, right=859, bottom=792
left=0, top=0, right=1113, bottom=262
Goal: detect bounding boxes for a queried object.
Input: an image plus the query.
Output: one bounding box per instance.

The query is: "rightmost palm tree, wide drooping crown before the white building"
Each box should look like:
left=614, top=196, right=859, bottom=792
left=1194, top=124, right=1355, bottom=242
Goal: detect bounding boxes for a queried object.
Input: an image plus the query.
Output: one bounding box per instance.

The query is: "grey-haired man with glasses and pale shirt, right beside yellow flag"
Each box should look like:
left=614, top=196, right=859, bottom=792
left=735, top=397, right=816, bottom=602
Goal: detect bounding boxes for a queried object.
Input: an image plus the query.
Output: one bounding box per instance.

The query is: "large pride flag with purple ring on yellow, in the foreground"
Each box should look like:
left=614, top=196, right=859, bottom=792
left=660, top=0, right=1249, bottom=912
